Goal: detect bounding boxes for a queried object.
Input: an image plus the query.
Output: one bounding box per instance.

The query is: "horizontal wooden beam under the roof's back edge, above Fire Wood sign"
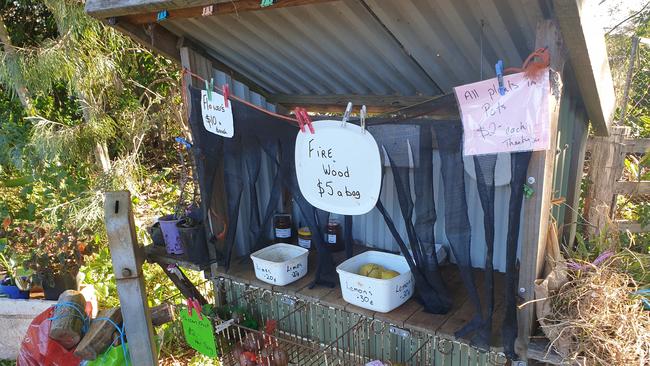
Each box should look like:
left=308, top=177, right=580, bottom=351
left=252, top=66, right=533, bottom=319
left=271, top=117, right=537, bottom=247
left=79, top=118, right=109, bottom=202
left=268, top=94, right=458, bottom=119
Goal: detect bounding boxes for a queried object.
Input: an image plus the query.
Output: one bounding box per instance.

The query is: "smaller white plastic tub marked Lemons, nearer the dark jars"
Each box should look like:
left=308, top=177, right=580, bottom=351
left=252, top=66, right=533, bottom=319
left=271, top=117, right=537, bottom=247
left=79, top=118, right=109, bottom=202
left=251, top=243, right=309, bottom=286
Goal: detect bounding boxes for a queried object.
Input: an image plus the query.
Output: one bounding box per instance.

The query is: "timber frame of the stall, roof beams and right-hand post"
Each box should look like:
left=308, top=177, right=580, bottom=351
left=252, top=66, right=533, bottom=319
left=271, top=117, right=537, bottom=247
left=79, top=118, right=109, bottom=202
left=86, top=0, right=615, bottom=360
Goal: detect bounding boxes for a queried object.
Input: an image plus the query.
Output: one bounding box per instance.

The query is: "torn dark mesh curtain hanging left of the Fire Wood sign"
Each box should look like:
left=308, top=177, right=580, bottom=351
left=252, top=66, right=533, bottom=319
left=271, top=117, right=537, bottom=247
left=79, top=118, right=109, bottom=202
left=185, top=88, right=336, bottom=286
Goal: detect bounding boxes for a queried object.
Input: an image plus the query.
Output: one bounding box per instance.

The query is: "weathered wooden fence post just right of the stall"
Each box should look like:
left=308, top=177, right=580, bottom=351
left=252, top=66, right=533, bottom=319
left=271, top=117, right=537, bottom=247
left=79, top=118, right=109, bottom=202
left=584, top=126, right=629, bottom=237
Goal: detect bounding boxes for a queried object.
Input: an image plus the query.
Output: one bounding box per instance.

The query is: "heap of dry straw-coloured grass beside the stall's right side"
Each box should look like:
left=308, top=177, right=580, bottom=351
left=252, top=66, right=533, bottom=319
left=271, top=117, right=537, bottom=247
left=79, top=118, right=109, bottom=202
left=544, top=257, right=650, bottom=365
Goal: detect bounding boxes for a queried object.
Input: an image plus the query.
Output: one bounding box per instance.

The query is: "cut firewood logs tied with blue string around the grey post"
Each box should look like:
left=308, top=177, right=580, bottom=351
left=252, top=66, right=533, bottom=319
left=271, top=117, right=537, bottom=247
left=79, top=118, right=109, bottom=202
left=49, top=290, right=174, bottom=360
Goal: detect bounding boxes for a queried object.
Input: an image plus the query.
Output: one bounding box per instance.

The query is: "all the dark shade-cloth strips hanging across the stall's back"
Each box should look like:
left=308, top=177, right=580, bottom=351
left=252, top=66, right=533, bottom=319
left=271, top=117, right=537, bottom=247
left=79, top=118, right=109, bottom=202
left=189, top=87, right=530, bottom=358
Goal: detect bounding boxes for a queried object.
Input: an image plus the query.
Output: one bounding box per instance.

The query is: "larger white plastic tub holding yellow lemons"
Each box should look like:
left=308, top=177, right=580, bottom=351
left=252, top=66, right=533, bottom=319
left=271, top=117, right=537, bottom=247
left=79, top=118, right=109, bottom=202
left=336, top=251, right=415, bottom=313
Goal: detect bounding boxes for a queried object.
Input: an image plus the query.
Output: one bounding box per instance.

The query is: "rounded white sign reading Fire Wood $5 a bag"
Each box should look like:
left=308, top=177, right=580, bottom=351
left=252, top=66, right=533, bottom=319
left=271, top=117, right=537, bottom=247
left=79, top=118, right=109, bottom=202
left=296, top=120, right=381, bottom=215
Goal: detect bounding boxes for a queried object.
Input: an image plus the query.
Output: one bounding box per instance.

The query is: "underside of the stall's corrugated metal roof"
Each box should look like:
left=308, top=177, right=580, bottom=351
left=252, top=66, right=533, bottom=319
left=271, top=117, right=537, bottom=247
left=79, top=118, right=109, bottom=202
left=161, top=0, right=543, bottom=96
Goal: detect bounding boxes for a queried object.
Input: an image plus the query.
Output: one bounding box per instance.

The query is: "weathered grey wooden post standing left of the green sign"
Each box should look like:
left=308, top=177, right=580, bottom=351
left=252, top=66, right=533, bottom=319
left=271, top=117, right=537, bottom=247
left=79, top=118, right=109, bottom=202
left=104, top=191, right=158, bottom=366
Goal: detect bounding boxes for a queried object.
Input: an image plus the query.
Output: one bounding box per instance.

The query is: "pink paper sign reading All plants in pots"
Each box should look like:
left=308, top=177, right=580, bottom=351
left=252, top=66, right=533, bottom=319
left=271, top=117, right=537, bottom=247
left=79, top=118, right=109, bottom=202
left=454, top=70, right=550, bottom=155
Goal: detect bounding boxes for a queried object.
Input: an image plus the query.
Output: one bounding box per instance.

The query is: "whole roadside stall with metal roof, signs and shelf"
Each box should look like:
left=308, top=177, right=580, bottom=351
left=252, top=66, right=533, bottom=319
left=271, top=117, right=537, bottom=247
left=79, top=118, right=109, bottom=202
left=86, top=0, right=613, bottom=365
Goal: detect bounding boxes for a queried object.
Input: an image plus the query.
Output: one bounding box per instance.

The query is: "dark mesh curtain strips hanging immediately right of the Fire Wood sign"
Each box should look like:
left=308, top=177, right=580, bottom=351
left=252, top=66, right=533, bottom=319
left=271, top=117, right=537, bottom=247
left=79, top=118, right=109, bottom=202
left=368, top=120, right=452, bottom=314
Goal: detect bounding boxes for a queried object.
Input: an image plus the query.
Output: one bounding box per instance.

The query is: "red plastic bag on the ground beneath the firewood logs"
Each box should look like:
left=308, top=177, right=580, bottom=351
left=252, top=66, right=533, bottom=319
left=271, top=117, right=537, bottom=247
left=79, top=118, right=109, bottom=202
left=16, top=307, right=81, bottom=366
